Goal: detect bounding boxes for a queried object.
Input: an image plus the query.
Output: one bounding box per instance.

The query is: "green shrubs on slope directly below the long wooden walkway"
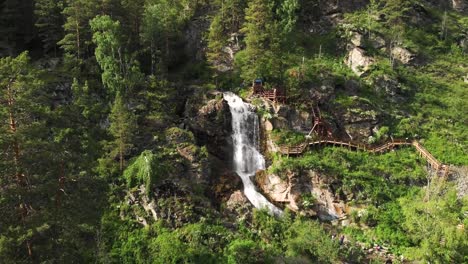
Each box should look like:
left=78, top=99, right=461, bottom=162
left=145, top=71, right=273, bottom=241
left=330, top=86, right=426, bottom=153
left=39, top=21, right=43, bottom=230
left=271, top=148, right=426, bottom=203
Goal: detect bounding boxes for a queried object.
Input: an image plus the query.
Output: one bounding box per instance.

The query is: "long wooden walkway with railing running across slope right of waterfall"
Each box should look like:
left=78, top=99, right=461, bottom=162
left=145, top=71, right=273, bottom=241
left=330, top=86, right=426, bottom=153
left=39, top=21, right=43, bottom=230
left=280, top=139, right=450, bottom=177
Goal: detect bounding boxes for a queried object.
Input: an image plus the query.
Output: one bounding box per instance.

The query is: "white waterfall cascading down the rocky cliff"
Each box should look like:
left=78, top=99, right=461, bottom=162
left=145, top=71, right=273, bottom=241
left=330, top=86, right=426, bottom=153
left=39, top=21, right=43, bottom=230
left=224, top=92, right=282, bottom=215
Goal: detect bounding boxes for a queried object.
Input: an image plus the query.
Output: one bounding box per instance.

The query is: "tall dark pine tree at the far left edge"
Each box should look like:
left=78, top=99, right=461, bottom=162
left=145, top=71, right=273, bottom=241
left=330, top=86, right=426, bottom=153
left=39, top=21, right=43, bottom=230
left=0, top=53, right=49, bottom=258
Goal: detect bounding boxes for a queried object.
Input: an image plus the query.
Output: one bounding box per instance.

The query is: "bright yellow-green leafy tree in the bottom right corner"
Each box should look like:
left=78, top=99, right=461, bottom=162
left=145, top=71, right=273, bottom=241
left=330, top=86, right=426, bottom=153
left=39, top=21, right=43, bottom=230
left=400, top=182, right=468, bottom=263
